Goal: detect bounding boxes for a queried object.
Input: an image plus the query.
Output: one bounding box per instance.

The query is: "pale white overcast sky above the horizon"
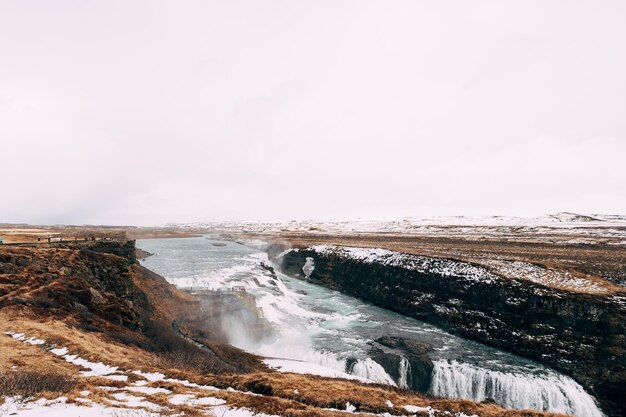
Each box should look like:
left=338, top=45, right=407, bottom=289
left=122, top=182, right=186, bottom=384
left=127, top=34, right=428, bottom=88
left=0, top=0, right=626, bottom=225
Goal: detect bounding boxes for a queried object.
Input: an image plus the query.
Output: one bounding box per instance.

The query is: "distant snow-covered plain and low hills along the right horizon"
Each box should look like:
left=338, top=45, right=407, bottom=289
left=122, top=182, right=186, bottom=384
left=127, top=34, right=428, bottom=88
left=168, top=212, right=626, bottom=245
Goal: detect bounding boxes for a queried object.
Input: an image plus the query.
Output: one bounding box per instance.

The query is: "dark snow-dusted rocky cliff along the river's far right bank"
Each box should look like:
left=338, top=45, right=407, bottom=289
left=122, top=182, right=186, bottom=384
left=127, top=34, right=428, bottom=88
left=278, top=247, right=626, bottom=415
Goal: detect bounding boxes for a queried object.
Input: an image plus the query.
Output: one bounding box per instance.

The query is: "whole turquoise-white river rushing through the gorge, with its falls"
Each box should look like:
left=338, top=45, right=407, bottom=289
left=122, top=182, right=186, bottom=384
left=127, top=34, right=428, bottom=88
left=138, top=238, right=602, bottom=417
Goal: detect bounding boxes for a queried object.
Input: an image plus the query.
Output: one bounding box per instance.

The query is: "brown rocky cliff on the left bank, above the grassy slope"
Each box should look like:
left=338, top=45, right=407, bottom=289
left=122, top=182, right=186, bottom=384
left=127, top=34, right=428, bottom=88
left=0, top=240, right=265, bottom=372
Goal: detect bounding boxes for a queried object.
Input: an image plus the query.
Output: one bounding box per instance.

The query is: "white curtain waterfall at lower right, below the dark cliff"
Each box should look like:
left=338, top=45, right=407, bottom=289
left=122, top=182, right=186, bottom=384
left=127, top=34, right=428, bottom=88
left=430, top=360, right=604, bottom=417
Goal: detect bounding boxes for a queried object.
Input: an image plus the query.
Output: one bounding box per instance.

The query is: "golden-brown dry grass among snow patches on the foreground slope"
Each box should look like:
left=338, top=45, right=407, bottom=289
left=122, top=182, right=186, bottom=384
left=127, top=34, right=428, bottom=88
left=0, top=308, right=564, bottom=417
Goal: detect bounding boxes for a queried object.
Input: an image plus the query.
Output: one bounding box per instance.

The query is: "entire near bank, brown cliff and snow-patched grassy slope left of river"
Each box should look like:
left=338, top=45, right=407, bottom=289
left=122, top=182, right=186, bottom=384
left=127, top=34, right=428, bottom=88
left=0, top=241, right=564, bottom=417
